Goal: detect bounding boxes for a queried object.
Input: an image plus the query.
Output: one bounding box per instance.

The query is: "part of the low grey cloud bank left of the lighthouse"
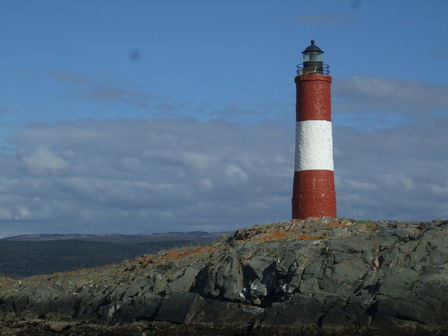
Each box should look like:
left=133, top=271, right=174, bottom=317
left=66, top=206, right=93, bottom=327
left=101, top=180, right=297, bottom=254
left=0, top=120, right=293, bottom=232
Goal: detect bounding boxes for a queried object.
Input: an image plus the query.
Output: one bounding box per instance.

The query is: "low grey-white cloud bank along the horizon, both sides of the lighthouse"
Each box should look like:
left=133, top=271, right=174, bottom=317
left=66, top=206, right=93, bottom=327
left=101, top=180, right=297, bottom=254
left=0, top=113, right=448, bottom=234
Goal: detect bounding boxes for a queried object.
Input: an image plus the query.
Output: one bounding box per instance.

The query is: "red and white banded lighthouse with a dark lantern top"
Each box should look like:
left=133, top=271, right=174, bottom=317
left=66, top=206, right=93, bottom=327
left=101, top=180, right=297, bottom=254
left=292, top=40, right=336, bottom=219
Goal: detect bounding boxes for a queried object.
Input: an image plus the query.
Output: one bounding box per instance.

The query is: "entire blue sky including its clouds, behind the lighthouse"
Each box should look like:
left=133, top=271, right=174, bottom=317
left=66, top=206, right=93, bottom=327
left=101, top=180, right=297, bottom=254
left=0, top=0, right=448, bottom=235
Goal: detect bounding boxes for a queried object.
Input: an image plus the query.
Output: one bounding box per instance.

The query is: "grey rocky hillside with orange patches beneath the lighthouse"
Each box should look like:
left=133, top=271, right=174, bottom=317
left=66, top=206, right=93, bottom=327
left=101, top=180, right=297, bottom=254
left=0, top=218, right=448, bottom=336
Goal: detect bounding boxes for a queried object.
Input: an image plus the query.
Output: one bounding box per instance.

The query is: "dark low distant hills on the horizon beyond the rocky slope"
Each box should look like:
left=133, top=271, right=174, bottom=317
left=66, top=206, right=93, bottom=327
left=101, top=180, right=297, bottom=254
left=0, top=232, right=228, bottom=278
